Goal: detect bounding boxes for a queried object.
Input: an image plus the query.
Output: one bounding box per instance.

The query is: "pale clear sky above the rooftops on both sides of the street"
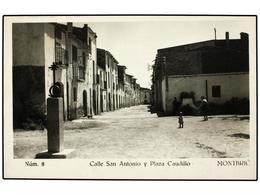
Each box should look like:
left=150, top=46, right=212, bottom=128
left=74, top=17, right=255, bottom=88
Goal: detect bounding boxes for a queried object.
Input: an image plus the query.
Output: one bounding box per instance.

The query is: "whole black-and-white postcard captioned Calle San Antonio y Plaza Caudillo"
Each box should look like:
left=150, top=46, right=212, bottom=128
left=3, top=15, right=257, bottom=180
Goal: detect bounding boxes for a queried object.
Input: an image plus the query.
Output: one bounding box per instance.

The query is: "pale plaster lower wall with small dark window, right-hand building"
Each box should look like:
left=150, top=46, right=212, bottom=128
left=165, top=73, right=249, bottom=112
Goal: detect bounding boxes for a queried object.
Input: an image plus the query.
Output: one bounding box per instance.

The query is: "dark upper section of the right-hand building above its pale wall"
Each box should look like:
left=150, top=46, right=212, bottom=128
left=154, top=33, right=249, bottom=75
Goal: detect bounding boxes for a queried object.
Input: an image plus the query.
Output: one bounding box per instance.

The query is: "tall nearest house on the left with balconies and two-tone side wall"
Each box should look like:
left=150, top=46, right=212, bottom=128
left=12, top=23, right=97, bottom=127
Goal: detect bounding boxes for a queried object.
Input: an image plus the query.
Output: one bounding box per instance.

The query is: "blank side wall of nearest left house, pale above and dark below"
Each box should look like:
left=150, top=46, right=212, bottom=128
left=12, top=23, right=59, bottom=126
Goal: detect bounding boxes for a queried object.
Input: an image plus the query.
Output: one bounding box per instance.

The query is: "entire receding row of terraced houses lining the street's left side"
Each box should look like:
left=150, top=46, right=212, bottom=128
left=12, top=23, right=150, bottom=128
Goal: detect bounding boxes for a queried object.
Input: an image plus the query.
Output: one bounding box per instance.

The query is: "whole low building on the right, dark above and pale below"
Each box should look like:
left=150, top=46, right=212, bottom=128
left=152, top=32, right=249, bottom=114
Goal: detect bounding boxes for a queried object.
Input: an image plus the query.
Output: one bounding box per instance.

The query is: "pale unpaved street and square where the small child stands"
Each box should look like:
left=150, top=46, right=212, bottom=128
left=14, top=105, right=249, bottom=159
